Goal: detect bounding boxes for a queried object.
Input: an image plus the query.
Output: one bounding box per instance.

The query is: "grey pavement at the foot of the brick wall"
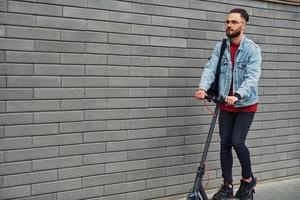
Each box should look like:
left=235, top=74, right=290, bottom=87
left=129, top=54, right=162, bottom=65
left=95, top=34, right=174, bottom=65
left=174, top=176, right=300, bottom=200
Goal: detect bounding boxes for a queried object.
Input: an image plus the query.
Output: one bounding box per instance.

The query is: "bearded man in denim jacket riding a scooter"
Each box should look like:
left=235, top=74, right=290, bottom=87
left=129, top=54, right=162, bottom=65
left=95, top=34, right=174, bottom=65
left=195, top=8, right=261, bottom=200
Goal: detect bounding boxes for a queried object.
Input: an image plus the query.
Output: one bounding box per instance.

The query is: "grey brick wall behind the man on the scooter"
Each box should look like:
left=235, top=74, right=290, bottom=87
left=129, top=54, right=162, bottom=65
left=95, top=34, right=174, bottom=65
left=0, top=0, right=300, bottom=200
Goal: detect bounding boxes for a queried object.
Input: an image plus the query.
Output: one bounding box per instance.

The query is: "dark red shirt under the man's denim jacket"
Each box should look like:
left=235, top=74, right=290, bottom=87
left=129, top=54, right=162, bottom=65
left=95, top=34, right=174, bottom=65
left=220, top=43, right=258, bottom=112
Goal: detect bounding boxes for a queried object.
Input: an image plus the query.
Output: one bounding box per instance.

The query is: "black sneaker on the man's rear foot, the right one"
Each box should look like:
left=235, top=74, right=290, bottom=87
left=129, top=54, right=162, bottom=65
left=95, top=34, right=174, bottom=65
left=235, top=177, right=257, bottom=200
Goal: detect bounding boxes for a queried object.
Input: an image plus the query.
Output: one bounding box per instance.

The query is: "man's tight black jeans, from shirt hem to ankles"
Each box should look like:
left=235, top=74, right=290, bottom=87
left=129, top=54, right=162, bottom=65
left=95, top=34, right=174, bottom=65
left=219, top=110, right=255, bottom=182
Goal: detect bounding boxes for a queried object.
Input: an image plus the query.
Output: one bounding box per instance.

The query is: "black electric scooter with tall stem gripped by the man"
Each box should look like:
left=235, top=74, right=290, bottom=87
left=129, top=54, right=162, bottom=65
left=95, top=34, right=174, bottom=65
left=186, top=96, right=253, bottom=200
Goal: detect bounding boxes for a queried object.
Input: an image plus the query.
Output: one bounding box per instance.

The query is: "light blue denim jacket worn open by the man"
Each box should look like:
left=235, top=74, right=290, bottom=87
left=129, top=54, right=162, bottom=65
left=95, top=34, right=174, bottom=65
left=199, top=36, right=262, bottom=107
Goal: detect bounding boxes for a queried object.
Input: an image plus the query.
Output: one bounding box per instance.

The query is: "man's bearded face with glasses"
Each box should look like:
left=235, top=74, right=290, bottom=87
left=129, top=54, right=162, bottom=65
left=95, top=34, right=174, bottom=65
left=226, top=13, right=246, bottom=38
